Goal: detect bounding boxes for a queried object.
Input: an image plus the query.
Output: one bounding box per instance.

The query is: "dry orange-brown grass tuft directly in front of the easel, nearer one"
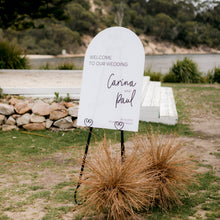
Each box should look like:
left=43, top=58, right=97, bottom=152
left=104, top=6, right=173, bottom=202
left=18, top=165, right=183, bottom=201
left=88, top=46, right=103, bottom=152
left=78, top=139, right=154, bottom=220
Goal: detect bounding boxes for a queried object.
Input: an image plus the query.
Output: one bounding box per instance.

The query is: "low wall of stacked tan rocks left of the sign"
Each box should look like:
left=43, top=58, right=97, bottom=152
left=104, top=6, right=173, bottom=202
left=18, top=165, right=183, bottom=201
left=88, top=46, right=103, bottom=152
left=0, top=98, right=78, bottom=131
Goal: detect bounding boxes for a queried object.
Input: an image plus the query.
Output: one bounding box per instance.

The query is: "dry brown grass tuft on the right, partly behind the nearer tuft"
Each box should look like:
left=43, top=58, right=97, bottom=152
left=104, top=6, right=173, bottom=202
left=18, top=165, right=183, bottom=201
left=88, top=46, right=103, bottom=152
left=135, top=131, right=193, bottom=210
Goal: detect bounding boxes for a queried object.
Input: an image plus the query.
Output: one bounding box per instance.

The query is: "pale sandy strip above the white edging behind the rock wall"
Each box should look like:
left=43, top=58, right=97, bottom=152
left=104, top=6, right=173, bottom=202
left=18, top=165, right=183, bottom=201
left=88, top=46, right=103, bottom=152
left=0, top=70, right=82, bottom=88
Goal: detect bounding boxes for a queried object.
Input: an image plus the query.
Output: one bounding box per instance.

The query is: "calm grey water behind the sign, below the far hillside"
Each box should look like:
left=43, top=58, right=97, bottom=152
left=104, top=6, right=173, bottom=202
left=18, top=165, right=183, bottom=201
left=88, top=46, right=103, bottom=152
left=30, top=54, right=220, bottom=74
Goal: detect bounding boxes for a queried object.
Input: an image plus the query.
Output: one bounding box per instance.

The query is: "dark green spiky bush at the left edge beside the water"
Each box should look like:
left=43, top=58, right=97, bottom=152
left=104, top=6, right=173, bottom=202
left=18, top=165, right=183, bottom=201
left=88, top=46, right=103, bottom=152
left=0, top=41, right=28, bottom=69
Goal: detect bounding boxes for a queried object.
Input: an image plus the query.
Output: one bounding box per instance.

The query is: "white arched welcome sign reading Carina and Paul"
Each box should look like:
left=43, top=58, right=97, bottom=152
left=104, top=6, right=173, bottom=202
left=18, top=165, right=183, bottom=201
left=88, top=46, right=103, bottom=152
left=77, top=27, right=145, bottom=131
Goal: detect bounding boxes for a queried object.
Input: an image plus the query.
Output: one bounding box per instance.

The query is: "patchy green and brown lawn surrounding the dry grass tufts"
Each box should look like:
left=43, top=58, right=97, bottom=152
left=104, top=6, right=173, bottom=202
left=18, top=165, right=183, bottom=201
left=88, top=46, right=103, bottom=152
left=0, top=84, right=220, bottom=220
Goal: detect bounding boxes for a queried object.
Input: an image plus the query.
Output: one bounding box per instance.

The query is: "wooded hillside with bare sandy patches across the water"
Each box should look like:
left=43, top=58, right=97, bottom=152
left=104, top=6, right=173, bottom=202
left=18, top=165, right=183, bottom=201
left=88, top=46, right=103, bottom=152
left=0, top=0, right=220, bottom=55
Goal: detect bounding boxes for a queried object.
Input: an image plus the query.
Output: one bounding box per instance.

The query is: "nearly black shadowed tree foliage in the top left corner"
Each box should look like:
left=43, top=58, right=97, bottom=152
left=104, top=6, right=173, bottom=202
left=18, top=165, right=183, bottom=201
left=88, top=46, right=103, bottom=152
left=0, top=0, right=71, bottom=30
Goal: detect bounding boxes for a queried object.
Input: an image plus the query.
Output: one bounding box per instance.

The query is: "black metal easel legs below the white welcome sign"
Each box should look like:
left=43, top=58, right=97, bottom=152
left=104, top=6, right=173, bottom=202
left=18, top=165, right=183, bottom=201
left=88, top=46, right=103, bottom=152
left=74, top=127, right=125, bottom=205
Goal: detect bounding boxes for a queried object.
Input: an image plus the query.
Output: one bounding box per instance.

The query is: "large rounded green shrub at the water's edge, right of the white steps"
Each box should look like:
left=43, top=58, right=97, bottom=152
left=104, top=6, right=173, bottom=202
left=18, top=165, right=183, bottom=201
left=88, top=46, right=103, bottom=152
left=169, top=57, right=202, bottom=83
